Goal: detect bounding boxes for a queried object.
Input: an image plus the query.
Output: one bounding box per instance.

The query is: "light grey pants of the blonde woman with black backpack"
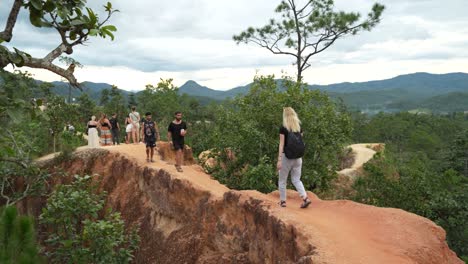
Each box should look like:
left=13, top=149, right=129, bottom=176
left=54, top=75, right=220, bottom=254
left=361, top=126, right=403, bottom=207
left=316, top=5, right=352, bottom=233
left=278, top=153, right=307, bottom=201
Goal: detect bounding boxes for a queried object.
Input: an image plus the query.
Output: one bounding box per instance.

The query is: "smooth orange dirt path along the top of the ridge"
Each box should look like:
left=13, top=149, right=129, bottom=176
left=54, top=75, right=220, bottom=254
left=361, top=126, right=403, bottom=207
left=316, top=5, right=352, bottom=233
left=95, top=144, right=454, bottom=264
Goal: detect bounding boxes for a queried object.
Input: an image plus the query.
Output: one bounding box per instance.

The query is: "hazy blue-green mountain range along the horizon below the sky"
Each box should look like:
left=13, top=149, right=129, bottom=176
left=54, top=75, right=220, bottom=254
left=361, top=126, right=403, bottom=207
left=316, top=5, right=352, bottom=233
left=6, top=73, right=468, bottom=113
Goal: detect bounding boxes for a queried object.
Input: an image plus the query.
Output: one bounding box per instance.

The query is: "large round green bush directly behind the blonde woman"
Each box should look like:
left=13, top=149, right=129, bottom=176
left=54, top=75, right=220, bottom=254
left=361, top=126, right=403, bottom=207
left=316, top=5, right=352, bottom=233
left=193, top=76, right=351, bottom=191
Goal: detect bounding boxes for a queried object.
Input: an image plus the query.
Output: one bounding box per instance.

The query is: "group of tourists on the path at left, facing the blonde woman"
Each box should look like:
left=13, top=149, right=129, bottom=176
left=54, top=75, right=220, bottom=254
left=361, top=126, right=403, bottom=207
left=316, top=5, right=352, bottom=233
left=88, top=107, right=187, bottom=172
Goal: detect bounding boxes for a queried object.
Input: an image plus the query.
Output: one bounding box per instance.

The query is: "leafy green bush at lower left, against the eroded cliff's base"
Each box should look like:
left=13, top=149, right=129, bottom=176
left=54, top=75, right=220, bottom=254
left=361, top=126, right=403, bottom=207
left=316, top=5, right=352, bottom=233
left=39, top=176, right=139, bottom=263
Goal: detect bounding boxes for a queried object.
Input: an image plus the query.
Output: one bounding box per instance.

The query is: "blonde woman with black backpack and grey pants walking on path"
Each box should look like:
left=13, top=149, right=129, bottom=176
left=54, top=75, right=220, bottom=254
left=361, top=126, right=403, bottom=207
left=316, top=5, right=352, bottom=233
left=276, top=107, right=311, bottom=208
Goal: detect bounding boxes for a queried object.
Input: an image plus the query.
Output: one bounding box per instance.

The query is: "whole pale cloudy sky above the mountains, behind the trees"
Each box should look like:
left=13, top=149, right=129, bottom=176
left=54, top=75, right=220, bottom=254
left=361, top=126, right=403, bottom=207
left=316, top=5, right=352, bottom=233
left=0, top=0, right=468, bottom=90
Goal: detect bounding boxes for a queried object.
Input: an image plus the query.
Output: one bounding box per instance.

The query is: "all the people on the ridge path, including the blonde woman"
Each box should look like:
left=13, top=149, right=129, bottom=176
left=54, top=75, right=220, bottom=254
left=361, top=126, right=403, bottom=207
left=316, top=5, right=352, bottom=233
left=88, top=107, right=311, bottom=208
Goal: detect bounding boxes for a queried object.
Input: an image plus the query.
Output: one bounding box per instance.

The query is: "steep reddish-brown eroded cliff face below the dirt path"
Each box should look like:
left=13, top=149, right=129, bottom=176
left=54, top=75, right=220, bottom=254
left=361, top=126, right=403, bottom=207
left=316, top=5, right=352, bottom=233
left=30, top=150, right=313, bottom=263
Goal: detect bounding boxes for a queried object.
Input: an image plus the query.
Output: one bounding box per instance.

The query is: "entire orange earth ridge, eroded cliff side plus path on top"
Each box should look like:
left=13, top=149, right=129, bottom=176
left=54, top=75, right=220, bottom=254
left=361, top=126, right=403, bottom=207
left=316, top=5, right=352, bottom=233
left=26, top=146, right=462, bottom=264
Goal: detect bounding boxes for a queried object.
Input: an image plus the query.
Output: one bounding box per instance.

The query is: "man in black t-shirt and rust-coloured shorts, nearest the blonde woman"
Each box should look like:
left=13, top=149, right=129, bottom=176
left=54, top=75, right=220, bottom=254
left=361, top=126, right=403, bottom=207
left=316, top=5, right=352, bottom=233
left=167, top=112, right=187, bottom=172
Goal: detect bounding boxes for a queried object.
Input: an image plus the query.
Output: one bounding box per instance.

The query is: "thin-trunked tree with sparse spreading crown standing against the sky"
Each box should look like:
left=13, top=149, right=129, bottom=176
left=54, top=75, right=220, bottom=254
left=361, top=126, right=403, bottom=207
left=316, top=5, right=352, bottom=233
left=233, top=0, right=385, bottom=82
